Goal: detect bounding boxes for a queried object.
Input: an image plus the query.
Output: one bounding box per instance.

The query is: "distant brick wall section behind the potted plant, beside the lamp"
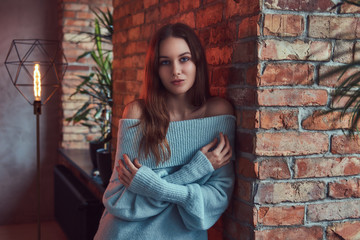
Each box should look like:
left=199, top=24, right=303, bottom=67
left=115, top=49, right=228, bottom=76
left=61, top=0, right=112, bottom=148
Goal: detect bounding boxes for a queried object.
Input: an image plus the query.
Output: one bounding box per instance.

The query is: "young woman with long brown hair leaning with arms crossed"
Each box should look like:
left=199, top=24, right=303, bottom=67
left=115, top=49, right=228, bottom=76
left=95, top=23, right=235, bottom=240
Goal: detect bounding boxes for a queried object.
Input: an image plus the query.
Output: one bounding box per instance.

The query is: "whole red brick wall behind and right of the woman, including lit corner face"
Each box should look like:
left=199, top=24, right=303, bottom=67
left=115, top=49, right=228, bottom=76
left=113, top=0, right=360, bottom=240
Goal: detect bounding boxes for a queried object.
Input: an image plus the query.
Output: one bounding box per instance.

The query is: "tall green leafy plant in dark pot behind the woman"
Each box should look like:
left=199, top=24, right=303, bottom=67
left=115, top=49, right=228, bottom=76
left=66, top=9, right=113, bottom=186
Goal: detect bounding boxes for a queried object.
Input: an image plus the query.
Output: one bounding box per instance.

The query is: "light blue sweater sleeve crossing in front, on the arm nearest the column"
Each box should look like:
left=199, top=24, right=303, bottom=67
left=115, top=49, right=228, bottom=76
left=129, top=162, right=234, bottom=230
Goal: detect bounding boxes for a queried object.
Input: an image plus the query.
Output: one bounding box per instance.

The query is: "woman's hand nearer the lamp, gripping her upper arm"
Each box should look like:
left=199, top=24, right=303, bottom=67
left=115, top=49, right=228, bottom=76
left=116, top=154, right=141, bottom=187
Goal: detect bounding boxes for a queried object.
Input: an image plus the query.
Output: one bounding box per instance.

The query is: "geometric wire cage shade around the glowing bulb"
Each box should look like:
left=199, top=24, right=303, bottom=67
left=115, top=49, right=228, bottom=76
left=5, top=39, right=67, bottom=105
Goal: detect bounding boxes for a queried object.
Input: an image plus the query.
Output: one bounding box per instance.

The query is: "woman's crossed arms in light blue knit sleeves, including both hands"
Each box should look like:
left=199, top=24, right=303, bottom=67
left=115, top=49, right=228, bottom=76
left=104, top=134, right=234, bottom=229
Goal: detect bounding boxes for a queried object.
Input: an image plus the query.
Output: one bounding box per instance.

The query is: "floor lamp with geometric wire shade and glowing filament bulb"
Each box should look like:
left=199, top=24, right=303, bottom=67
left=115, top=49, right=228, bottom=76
left=5, top=39, right=67, bottom=240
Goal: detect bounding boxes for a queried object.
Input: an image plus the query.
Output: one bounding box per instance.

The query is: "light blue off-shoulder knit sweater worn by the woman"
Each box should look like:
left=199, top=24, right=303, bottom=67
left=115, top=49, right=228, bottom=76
left=94, top=115, right=235, bottom=240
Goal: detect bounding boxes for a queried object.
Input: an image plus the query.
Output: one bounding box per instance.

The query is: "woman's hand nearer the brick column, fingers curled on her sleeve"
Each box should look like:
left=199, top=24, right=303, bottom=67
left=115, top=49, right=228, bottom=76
left=200, top=133, right=232, bottom=170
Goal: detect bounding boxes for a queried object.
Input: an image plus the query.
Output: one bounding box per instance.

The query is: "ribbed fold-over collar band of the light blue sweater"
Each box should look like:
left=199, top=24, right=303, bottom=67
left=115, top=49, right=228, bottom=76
left=116, top=115, right=235, bottom=169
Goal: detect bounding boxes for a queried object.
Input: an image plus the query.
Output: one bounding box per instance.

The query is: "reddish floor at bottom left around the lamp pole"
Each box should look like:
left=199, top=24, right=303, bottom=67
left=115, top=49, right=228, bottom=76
left=0, top=221, right=67, bottom=240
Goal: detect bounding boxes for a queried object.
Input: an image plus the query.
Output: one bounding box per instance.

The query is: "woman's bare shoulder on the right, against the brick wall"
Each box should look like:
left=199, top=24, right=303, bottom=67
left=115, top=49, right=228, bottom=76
left=206, top=97, right=234, bottom=117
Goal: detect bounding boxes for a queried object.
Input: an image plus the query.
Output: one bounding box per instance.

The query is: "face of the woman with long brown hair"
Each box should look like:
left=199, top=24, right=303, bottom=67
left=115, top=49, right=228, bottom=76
left=159, top=37, right=196, bottom=95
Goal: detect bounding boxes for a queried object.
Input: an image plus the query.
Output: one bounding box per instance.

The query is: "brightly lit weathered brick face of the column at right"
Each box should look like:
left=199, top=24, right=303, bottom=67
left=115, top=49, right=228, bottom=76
left=253, top=0, right=360, bottom=240
